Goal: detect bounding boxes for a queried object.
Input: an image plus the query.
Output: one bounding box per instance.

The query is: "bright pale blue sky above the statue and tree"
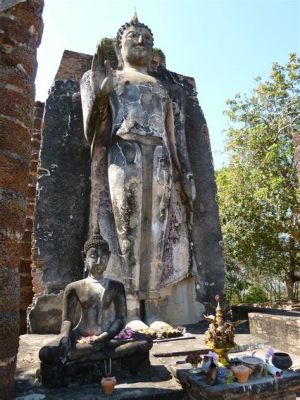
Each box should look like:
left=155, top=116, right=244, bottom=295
left=36, top=0, right=300, bottom=169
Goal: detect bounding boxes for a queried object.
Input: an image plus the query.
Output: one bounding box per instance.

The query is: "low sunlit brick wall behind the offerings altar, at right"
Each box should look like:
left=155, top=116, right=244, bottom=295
left=248, top=313, right=300, bottom=355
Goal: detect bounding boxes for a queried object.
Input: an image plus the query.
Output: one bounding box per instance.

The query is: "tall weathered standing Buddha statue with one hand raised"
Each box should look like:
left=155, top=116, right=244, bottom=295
left=81, top=15, right=200, bottom=323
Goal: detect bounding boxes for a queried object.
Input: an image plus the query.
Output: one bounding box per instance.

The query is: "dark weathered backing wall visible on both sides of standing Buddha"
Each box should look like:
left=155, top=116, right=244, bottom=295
left=29, top=39, right=224, bottom=333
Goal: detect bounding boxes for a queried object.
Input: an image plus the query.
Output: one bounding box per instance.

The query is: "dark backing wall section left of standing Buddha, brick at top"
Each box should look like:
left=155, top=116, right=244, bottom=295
left=27, top=50, right=92, bottom=333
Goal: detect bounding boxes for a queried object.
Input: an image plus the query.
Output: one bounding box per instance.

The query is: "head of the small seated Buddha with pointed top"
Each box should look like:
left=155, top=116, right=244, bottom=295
left=83, top=225, right=110, bottom=279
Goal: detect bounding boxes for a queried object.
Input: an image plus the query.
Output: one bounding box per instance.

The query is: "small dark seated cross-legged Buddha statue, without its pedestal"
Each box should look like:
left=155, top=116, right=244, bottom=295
left=39, top=227, right=152, bottom=364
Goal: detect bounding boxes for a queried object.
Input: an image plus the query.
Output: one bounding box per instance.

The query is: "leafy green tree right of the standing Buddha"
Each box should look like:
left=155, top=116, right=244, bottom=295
left=217, top=54, right=300, bottom=300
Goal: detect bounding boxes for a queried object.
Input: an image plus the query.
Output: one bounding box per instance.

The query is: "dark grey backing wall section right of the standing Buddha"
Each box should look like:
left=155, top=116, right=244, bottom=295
left=150, top=66, right=225, bottom=303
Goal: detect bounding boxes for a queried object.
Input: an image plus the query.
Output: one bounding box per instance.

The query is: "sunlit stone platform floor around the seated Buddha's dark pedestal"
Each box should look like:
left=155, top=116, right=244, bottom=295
left=15, top=323, right=300, bottom=400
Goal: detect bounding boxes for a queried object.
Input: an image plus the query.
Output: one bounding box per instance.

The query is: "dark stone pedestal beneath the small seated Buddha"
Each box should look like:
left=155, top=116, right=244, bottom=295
left=40, top=350, right=150, bottom=388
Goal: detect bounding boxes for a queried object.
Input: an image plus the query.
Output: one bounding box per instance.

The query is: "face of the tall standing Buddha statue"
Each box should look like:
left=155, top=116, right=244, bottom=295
left=121, top=25, right=153, bottom=67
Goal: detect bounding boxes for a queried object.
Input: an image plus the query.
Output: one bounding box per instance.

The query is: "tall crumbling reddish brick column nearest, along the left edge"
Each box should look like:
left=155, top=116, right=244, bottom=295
left=0, top=0, right=43, bottom=399
